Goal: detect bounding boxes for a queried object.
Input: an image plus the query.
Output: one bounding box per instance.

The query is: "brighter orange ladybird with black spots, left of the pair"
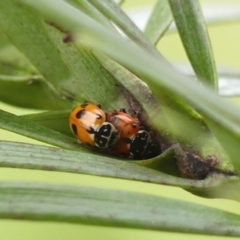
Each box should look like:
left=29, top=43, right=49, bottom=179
left=69, top=103, right=119, bottom=148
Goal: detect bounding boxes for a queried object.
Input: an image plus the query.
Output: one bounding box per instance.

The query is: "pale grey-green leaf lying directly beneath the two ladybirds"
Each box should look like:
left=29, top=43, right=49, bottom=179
left=0, top=141, right=182, bottom=186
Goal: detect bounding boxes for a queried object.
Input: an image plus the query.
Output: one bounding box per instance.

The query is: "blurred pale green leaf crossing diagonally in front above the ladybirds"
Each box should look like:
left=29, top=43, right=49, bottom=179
left=21, top=0, right=240, bottom=171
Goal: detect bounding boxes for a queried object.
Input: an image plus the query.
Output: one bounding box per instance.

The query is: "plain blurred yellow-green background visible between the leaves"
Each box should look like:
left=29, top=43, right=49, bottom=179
left=0, top=0, right=240, bottom=240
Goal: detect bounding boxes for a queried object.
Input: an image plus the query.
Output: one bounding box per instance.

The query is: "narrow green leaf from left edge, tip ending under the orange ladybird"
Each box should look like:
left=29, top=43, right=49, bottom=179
left=0, top=110, right=89, bottom=151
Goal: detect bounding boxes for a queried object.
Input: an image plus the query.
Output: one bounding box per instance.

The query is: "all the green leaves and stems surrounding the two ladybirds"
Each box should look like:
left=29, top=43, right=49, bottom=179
left=0, top=0, right=240, bottom=236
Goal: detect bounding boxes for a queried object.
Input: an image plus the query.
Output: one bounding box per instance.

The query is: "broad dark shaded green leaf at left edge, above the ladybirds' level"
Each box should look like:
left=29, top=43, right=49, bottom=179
left=0, top=75, right=71, bottom=109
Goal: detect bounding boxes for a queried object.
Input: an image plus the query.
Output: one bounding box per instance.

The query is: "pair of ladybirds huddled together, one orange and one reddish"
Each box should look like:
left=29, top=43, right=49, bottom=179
left=69, top=103, right=156, bottom=159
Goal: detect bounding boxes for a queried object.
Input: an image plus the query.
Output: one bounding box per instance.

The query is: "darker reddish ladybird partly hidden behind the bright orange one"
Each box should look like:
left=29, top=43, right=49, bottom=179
left=106, top=109, right=150, bottom=159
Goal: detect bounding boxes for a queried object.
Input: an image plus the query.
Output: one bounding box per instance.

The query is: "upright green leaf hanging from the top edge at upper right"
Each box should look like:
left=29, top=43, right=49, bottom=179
left=168, top=0, right=218, bottom=89
